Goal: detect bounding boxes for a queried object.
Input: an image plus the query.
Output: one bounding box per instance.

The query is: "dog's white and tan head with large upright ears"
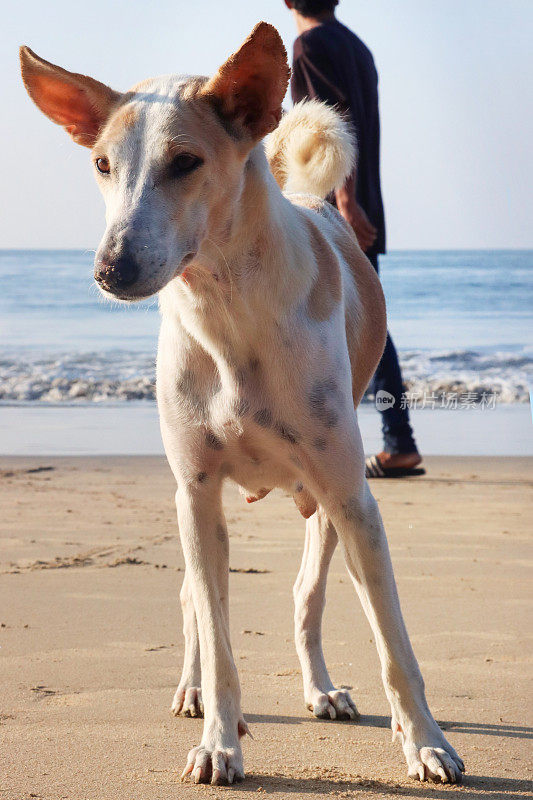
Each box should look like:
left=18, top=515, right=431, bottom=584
left=20, top=22, right=289, bottom=300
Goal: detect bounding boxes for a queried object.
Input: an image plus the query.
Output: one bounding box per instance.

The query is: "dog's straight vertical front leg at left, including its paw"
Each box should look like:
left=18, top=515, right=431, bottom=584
left=176, top=481, right=246, bottom=784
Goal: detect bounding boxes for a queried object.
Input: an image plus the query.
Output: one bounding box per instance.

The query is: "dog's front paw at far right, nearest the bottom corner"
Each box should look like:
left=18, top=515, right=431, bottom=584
left=402, top=722, right=465, bottom=783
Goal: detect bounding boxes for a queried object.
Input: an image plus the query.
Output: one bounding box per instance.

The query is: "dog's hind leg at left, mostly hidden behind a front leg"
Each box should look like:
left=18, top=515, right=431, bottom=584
left=171, top=569, right=204, bottom=717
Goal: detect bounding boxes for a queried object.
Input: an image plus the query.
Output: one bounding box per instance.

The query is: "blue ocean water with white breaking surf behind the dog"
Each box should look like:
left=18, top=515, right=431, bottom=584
left=0, top=250, right=533, bottom=405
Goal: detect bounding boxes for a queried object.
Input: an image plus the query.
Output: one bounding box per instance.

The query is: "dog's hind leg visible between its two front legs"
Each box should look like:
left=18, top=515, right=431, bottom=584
left=293, top=509, right=358, bottom=719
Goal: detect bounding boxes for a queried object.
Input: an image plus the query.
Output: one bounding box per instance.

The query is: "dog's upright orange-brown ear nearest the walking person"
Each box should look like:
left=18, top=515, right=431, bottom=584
left=202, top=22, right=290, bottom=139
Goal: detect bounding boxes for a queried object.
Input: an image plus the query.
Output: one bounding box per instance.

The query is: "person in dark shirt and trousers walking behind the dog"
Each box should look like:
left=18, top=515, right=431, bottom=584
left=285, top=0, right=424, bottom=478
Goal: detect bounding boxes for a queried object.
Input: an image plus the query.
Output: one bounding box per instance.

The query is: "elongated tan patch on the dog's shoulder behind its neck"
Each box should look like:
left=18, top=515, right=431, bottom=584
left=307, top=220, right=342, bottom=322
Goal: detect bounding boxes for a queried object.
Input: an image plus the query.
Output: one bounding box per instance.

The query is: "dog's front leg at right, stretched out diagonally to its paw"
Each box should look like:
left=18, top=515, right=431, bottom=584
left=315, top=420, right=464, bottom=783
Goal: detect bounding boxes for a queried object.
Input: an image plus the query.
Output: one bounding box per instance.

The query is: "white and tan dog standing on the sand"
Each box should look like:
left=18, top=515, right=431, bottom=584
left=21, top=23, right=464, bottom=784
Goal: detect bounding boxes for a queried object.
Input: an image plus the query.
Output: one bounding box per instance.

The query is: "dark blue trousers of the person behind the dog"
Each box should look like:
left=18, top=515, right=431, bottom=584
left=369, top=255, right=417, bottom=453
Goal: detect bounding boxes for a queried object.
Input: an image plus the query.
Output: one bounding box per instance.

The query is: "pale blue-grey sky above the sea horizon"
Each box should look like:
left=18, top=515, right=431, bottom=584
left=4, top=0, right=533, bottom=249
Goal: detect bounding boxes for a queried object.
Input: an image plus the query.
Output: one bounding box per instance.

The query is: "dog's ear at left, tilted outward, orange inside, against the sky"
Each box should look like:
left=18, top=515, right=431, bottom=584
left=20, top=47, right=121, bottom=147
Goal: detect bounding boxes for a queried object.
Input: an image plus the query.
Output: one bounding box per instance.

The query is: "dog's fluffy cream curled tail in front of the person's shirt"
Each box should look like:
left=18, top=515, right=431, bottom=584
left=266, top=100, right=356, bottom=198
